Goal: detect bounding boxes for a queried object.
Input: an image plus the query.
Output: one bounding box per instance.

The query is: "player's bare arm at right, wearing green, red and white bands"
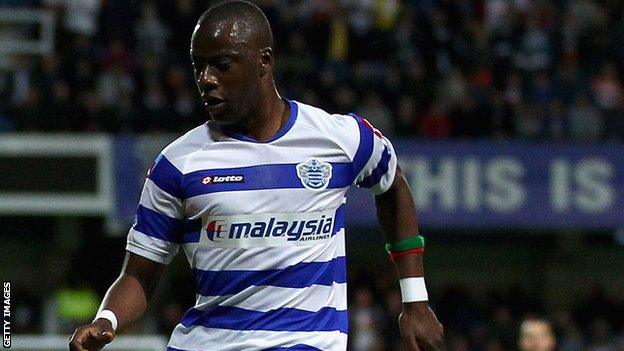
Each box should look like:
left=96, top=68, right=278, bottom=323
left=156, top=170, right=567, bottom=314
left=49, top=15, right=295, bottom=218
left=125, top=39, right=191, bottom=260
left=375, top=166, right=444, bottom=351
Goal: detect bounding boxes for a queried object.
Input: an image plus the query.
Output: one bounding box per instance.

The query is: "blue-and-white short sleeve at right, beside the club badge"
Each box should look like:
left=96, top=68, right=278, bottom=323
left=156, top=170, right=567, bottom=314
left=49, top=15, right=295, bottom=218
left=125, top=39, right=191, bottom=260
left=352, top=115, right=397, bottom=195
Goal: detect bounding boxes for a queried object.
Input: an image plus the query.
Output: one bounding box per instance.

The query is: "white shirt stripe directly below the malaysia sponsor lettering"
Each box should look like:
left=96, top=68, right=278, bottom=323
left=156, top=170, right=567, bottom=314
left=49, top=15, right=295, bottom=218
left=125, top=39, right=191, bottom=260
left=184, top=228, right=346, bottom=271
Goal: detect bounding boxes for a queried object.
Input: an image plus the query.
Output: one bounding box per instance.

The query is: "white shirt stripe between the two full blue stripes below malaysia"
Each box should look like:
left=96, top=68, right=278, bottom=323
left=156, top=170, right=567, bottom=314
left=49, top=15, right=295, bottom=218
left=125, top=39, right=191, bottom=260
left=195, top=282, right=347, bottom=312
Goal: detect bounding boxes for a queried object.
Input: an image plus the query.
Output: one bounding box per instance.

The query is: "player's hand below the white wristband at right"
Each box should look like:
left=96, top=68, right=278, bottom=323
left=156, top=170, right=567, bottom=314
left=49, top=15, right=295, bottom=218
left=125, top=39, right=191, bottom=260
left=399, top=302, right=444, bottom=351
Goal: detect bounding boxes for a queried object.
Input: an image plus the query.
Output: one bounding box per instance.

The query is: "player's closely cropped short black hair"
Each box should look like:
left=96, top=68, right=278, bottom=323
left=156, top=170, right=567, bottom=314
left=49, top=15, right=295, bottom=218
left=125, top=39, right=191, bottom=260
left=199, top=0, right=273, bottom=48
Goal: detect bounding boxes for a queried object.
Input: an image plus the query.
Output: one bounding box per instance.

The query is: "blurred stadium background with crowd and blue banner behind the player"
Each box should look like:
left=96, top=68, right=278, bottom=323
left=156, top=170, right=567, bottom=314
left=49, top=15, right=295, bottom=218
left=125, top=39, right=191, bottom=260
left=0, top=0, right=624, bottom=351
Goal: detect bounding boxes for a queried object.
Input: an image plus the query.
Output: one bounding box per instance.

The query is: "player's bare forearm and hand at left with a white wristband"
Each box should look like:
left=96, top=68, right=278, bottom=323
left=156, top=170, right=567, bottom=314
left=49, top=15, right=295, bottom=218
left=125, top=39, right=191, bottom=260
left=69, top=252, right=164, bottom=351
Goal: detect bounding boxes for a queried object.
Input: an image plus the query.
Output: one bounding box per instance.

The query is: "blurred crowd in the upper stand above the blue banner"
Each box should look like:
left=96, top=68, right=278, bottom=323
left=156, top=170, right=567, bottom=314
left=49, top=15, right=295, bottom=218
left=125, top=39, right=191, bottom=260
left=0, top=0, right=624, bottom=141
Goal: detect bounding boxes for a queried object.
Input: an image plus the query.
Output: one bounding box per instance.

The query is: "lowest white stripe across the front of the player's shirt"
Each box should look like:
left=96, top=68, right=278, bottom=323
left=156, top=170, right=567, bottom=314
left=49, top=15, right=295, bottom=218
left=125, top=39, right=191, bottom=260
left=169, top=324, right=347, bottom=351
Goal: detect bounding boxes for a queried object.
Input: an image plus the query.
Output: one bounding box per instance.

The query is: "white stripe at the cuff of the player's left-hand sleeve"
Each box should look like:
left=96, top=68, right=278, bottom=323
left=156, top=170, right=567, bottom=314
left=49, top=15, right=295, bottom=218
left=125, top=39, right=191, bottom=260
left=126, top=228, right=180, bottom=264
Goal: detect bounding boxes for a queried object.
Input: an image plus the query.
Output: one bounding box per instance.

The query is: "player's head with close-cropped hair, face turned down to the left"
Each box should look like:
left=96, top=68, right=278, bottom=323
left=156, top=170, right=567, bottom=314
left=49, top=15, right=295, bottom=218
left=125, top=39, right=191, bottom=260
left=191, top=1, right=274, bottom=125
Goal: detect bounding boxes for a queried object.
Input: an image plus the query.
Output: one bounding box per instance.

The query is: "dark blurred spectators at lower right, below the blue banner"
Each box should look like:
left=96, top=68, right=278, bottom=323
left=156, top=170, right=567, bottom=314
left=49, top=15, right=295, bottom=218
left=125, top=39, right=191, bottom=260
left=349, top=270, right=624, bottom=351
